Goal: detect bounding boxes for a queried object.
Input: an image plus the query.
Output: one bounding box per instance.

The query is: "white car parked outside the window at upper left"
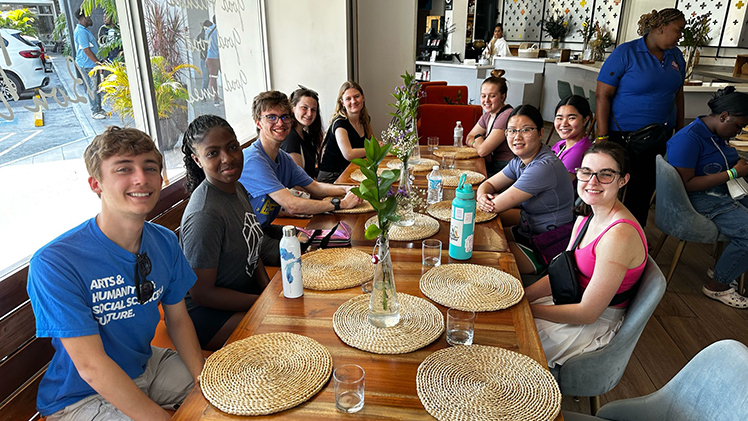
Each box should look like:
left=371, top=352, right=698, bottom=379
left=0, top=29, right=49, bottom=101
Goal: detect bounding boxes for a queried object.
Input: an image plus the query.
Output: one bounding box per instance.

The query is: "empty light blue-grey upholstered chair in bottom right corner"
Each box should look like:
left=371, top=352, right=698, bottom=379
left=564, top=339, right=748, bottom=421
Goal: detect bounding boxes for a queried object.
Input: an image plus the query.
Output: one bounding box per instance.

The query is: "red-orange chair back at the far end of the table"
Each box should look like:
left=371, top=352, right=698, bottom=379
left=418, top=104, right=483, bottom=145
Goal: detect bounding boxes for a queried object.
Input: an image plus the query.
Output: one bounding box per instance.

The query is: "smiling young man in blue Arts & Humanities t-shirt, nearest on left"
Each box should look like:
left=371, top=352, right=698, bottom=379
left=27, top=126, right=204, bottom=421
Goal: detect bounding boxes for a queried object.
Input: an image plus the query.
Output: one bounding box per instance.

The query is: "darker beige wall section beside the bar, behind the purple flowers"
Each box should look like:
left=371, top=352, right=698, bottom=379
left=357, top=0, right=418, bottom=138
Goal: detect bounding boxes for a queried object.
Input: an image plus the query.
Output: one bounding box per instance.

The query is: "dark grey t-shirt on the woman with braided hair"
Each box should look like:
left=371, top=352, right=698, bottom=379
left=179, top=180, right=262, bottom=310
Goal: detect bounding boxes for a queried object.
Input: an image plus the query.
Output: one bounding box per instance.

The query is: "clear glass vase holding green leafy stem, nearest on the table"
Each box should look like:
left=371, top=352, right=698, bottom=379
left=368, top=235, right=400, bottom=327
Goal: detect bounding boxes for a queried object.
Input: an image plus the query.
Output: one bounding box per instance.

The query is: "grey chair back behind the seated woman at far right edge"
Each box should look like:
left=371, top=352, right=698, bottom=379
left=655, top=155, right=719, bottom=243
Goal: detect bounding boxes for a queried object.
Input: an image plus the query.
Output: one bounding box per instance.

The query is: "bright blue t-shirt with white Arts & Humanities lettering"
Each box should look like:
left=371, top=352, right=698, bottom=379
left=27, top=218, right=197, bottom=416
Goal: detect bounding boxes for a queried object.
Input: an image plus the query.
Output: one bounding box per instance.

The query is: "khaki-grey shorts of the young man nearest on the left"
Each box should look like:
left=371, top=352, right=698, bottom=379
left=46, top=346, right=193, bottom=421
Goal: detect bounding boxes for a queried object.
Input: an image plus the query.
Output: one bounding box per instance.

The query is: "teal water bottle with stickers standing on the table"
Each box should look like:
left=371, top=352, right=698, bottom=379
left=449, top=174, right=475, bottom=260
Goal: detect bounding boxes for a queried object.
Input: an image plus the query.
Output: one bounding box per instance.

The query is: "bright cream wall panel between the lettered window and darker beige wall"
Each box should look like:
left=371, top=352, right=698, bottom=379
left=262, top=0, right=350, bottom=128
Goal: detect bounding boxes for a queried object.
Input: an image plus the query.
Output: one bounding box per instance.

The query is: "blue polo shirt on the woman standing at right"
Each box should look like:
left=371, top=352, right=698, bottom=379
left=597, top=35, right=686, bottom=132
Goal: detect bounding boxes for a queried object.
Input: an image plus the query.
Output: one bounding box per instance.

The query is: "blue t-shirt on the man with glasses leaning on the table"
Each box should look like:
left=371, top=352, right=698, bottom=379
left=239, top=139, right=314, bottom=227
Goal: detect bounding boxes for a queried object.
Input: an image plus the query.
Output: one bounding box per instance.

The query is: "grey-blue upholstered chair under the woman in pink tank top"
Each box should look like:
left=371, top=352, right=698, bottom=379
left=551, top=257, right=667, bottom=414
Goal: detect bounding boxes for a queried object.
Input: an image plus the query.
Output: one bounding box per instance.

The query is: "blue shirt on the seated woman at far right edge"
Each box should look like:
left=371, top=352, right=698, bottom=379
left=667, top=117, right=738, bottom=176
